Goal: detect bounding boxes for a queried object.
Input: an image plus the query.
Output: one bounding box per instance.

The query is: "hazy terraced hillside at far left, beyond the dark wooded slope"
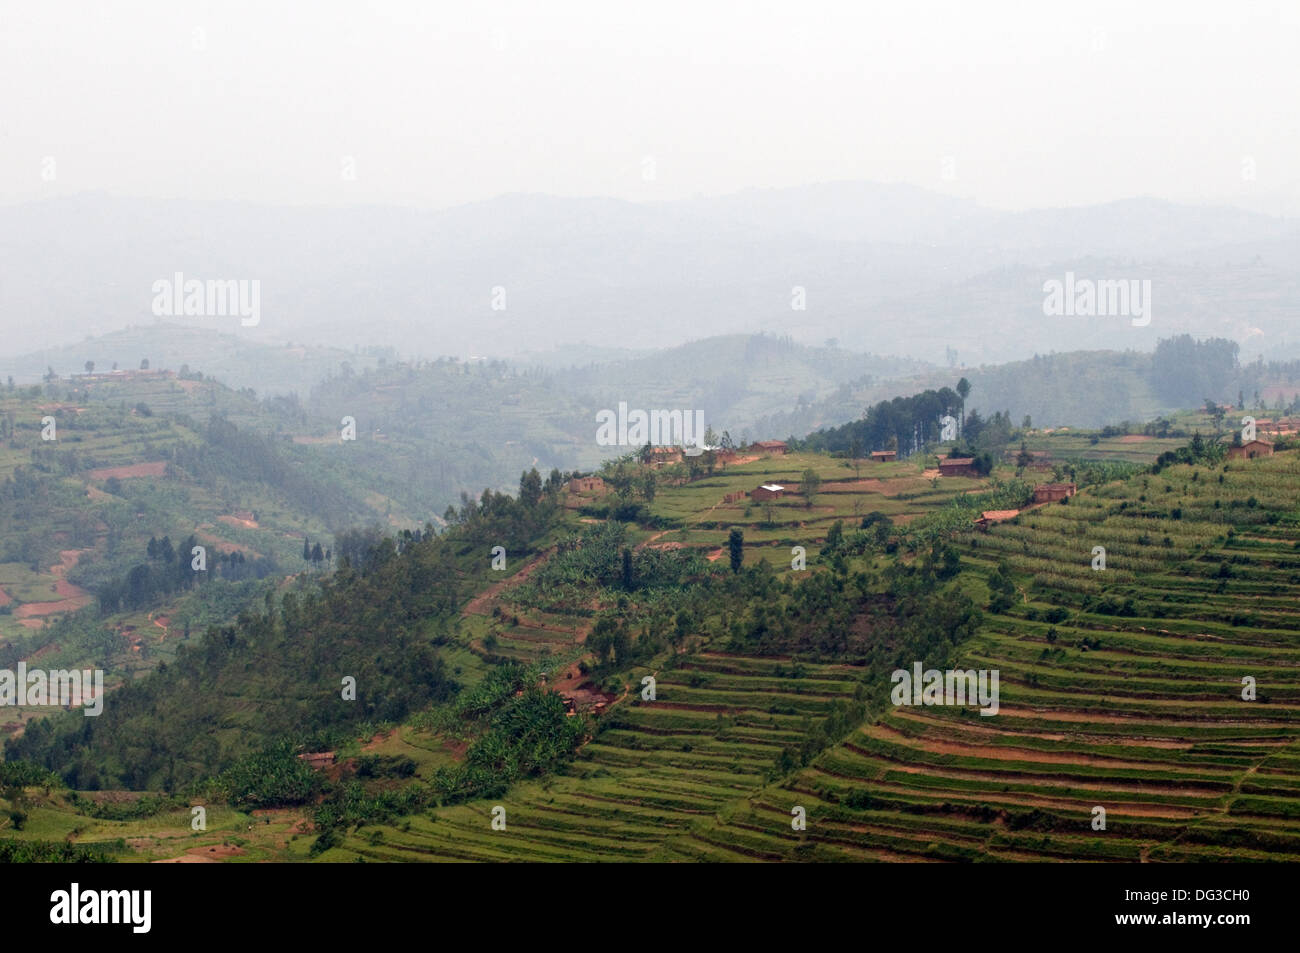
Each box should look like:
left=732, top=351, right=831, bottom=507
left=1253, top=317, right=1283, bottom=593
left=0, top=377, right=392, bottom=731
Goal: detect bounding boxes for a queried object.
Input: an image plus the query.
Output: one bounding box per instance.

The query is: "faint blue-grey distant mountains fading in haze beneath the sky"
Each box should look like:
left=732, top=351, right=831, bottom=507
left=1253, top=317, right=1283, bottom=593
left=0, top=182, right=1300, bottom=364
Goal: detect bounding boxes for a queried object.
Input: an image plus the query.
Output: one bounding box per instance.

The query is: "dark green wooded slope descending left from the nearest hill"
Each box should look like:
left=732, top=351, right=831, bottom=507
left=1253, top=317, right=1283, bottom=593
left=5, top=512, right=475, bottom=790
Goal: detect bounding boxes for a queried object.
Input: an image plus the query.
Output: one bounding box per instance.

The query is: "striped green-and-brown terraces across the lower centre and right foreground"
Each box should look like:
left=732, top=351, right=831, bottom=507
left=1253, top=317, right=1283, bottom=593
left=326, top=452, right=1300, bottom=861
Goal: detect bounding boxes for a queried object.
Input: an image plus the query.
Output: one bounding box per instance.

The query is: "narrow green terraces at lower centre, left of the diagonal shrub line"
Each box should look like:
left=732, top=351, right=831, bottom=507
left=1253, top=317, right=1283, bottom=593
left=333, top=653, right=855, bottom=861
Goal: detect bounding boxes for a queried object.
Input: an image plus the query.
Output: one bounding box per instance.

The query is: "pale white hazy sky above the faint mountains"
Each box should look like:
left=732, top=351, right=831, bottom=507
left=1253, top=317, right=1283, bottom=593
left=0, top=0, right=1300, bottom=208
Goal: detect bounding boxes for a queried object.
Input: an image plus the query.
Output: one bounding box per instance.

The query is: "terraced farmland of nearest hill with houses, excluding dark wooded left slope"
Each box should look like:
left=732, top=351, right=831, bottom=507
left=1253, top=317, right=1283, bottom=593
left=5, top=439, right=1300, bottom=862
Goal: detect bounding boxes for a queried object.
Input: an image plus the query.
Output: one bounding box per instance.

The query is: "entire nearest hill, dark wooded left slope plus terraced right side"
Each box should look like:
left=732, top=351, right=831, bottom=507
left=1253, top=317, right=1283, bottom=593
left=0, top=379, right=1300, bottom=861
